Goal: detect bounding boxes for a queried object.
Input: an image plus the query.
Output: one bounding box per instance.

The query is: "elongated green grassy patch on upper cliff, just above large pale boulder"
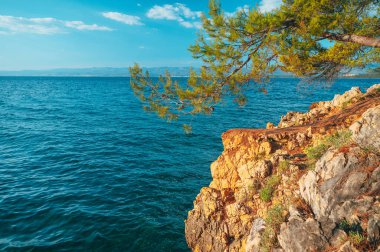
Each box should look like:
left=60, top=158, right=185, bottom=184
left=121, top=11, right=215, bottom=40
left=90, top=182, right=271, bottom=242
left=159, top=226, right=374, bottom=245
left=305, top=130, right=352, bottom=161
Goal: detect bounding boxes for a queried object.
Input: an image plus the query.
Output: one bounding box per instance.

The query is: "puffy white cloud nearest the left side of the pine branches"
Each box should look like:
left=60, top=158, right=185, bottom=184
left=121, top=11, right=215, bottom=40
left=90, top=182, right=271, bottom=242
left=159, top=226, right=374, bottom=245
left=146, top=3, right=201, bottom=28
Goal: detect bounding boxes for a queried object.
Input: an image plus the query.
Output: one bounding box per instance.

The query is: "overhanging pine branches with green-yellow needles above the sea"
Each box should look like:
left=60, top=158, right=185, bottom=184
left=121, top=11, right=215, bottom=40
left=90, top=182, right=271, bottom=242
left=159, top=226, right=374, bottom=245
left=130, top=0, right=380, bottom=121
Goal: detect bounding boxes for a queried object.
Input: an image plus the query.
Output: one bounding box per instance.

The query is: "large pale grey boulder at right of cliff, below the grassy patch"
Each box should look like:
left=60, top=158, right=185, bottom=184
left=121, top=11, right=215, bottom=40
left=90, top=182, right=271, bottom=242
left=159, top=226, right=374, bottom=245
left=299, top=144, right=380, bottom=236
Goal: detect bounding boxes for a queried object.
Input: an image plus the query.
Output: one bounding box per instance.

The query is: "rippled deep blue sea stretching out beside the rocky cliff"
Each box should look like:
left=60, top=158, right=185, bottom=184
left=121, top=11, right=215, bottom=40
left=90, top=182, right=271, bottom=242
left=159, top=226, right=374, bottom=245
left=0, top=77, right=380, bottom=251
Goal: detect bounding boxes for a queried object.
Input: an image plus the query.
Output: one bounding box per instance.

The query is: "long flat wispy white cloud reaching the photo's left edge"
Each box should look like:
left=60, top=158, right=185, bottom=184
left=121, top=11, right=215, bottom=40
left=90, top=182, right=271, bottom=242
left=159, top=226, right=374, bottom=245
left=0, top=15, right=112, bottom=35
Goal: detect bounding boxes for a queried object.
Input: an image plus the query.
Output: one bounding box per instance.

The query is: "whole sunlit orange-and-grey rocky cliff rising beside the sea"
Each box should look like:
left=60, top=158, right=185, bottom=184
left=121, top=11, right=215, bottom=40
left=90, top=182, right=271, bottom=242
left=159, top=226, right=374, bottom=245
left=185, top=84, right=380, bottom=252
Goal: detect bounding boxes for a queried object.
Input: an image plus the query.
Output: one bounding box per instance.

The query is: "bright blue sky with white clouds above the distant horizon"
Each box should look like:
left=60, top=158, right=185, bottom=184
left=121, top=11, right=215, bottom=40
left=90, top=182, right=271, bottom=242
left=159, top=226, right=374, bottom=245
left=0, top=0, right=281, bottom=70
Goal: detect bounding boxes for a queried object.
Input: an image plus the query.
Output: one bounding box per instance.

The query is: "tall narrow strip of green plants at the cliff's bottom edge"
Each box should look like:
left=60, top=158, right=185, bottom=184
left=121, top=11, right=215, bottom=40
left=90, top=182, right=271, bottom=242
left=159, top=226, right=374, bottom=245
left=260, top=205, right=285, bottom=252
